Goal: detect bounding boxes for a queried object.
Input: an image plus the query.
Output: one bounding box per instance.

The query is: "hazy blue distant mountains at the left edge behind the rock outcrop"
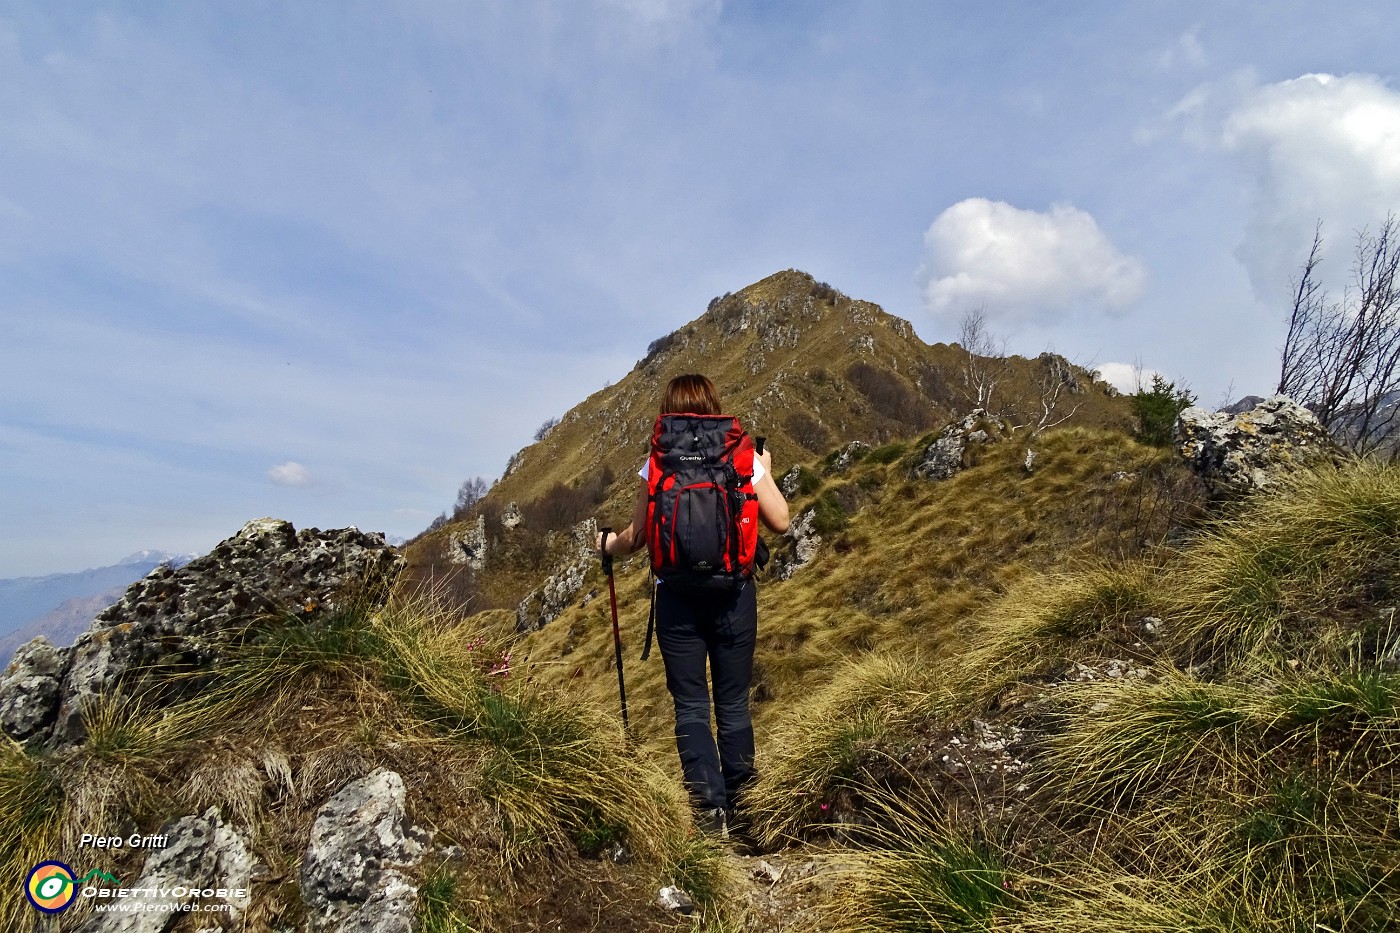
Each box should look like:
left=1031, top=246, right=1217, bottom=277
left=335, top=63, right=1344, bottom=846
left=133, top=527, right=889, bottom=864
left=0, top=551, right=195, bottom=665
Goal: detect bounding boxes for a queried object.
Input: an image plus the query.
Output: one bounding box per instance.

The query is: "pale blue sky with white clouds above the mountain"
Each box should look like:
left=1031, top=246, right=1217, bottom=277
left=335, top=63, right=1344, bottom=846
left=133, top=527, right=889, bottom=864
left=0, top=0, right=1400, bottom=577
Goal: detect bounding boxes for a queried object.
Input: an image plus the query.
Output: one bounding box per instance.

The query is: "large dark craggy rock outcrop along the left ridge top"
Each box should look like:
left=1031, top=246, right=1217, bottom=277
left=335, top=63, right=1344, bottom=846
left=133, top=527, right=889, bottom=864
left=0, top=518, right=403, bottom=747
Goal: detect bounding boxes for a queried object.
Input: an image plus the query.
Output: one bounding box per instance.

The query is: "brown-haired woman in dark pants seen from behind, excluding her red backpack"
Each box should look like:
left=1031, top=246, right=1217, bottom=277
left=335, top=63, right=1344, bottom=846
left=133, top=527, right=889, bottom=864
left=595, top=374, right=788, bottom=832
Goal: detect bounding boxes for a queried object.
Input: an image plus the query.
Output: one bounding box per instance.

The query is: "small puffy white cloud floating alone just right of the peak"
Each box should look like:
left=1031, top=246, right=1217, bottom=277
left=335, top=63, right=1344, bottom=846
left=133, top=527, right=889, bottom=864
left=920, top=198, right=1147, bottom=321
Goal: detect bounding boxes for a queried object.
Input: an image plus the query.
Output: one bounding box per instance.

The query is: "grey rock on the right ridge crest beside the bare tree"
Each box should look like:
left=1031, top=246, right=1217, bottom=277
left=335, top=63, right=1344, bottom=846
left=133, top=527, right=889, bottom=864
left=1175, top=395, right=1340, bottom=499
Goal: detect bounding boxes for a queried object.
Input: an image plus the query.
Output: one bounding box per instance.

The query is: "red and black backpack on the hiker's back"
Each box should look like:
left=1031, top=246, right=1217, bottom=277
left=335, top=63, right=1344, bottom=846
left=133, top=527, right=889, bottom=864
left=647, top=415, right=759, bottom=588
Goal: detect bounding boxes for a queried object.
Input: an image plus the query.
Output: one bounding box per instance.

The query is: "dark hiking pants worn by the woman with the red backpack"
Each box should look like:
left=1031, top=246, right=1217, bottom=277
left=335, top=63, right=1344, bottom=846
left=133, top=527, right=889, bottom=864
left=657, top=580, right=759, bottom=810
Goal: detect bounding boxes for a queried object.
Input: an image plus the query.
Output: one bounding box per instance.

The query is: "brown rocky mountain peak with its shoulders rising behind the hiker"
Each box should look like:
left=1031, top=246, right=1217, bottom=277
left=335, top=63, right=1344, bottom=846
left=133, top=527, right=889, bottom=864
left=406, top=270, right=1128, bottom=608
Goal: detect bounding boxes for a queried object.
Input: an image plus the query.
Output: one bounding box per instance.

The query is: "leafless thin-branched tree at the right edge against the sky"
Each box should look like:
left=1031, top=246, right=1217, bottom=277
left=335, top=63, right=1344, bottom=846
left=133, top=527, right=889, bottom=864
left=1278, top=214, right=1400, bottom=458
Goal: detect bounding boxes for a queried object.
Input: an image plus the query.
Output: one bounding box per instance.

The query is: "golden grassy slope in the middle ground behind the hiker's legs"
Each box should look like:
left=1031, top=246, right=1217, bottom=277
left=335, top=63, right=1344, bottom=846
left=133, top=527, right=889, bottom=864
left=512, top=429, right=1198, bottom=763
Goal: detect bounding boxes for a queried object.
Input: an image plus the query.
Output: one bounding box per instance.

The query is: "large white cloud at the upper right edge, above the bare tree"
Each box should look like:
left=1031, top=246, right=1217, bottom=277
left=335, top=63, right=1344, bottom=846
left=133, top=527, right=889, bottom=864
left=1173, top=74, right=1400, bottom=301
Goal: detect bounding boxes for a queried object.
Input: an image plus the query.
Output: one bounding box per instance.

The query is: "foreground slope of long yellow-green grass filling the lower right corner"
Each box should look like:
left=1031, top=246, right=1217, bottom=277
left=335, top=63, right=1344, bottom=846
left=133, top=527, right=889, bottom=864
left=760, top=465, right=1400, bottom=933
